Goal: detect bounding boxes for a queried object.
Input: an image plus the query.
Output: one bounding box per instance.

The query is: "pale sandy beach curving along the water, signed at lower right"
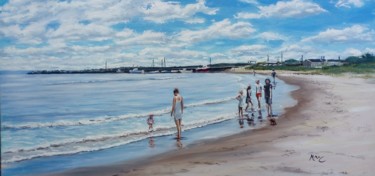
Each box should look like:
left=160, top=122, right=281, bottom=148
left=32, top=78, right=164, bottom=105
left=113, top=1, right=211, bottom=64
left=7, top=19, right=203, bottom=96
left=56, top=74, right=375, bottom=176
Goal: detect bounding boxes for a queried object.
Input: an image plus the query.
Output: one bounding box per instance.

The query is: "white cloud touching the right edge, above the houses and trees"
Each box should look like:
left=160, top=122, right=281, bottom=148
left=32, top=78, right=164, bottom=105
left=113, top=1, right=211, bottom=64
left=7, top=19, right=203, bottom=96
left=302, top=25, right=375, bottom=43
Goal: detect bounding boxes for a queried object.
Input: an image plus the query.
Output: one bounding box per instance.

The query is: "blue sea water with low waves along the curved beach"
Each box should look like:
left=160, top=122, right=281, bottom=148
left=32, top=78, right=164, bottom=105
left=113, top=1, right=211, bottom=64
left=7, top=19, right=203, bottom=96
left=0, top=72, right=296, bottom=175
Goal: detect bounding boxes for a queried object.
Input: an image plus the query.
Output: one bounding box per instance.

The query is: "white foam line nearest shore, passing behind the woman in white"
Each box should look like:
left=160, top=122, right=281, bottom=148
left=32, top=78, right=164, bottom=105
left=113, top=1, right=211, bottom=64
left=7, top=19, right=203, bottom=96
left=2, top=114, right=235, bottom=163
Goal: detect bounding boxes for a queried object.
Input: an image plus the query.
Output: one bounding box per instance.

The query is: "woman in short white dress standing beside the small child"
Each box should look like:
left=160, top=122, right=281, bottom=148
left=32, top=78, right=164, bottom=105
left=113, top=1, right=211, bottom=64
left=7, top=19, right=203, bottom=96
left=171, top=88, right=184, bottom=139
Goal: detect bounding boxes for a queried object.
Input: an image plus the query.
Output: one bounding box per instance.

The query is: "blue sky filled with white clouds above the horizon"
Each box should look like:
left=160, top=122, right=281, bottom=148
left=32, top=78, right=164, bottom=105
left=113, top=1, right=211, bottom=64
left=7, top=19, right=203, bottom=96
left=0, top=0, right=375, bottom=70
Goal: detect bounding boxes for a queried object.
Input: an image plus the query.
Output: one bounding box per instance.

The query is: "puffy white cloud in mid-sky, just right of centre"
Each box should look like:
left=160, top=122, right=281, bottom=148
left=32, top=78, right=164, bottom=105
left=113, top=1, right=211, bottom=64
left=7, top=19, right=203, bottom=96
left=176, top=19, right=255, bottom=43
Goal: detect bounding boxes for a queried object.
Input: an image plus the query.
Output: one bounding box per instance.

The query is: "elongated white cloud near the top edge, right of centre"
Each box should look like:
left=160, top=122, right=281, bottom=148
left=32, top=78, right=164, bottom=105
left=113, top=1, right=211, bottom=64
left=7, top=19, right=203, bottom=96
left=235, top=0, right=327, bottom=19
